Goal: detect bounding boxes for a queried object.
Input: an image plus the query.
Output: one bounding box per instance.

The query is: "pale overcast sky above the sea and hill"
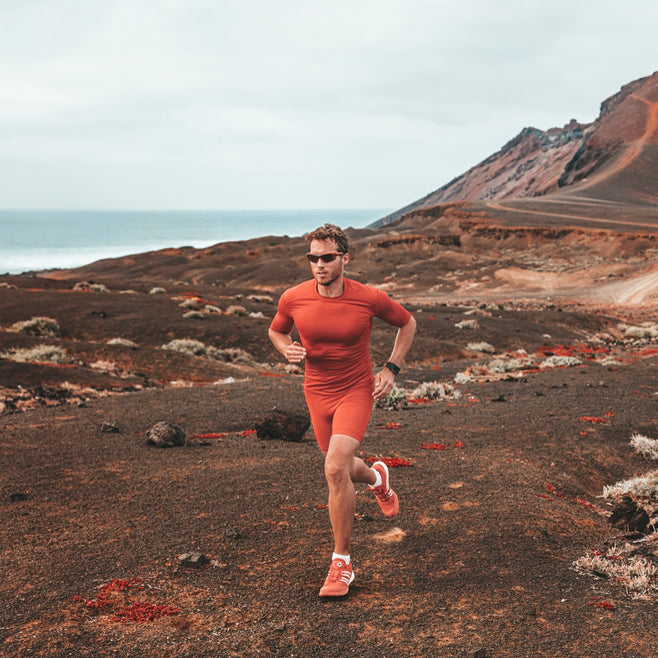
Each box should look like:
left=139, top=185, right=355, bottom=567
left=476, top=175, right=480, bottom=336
left=0, top=0, right=658, bottom=209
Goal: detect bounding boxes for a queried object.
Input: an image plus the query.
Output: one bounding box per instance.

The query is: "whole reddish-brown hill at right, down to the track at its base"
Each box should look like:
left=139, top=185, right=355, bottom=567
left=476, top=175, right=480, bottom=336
left=373, top=73, right=658, bottom=227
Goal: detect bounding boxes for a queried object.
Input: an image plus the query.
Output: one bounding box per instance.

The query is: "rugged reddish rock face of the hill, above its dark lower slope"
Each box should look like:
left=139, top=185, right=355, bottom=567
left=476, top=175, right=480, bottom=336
left=373, top=73, right=658, bottom=226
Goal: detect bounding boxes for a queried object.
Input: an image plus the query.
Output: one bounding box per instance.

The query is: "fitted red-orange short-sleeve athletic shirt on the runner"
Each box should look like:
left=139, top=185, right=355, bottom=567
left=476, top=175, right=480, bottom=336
left=270, top=279, right=411, bottom=391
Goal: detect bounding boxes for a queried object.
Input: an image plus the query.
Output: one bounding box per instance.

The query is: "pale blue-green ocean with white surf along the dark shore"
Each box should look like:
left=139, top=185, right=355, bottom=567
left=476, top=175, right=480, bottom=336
left=0, top=209, right=391, bottom=274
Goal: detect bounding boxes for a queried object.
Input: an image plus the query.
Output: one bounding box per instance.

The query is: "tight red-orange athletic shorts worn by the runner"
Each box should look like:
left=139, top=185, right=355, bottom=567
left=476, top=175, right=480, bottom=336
left=304, top=387, right=374, bottom=454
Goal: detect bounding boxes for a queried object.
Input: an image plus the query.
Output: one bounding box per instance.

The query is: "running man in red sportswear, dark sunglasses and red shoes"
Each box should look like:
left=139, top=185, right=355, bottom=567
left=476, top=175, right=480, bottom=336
left=269, top=224, right=416, bottom=596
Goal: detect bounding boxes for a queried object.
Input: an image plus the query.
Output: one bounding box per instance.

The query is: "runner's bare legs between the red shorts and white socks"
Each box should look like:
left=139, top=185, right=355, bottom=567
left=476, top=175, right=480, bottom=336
left=324, top=434, right=377, bottom=555
